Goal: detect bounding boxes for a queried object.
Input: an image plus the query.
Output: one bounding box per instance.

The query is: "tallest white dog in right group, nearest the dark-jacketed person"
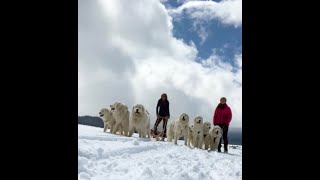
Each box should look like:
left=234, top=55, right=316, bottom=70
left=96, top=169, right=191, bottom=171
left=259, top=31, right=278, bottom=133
left=174, top=113, right=189, bottom=145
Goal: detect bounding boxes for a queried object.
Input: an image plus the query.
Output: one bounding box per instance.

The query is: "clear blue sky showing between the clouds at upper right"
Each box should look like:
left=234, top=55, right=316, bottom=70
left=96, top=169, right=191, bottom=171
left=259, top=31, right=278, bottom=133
left=163, top=0, right=242, bottom=65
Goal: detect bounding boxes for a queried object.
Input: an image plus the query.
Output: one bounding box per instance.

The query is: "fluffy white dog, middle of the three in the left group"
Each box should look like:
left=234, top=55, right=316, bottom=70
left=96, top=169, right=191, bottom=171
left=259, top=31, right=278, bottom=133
left=110, top=102, right=130, bottom=136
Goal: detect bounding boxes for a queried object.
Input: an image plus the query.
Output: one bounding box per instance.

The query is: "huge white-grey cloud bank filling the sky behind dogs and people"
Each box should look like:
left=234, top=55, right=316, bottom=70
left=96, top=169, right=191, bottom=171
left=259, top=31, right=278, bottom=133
left=78, top=0, right=242, bottom=127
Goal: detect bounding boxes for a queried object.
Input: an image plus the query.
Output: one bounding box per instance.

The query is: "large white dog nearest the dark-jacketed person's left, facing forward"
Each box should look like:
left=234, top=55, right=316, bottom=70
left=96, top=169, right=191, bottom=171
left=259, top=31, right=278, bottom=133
left=129, top=104, right=150, bottom=138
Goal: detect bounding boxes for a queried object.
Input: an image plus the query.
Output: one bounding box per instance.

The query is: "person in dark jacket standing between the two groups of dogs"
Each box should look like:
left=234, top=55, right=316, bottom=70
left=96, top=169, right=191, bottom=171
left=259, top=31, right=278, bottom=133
left=153, top=93, right=170, bottom=137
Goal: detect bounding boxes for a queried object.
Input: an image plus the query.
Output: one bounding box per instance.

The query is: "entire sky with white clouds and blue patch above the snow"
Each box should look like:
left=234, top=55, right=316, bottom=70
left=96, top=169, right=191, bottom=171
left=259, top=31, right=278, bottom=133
left=78, top=0, right=242, bottom=128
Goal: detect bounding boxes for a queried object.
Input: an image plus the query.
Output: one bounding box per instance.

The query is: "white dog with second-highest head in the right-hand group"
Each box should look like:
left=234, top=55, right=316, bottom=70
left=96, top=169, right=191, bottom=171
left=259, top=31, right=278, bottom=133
left=192, top=116, right=203, bottom=149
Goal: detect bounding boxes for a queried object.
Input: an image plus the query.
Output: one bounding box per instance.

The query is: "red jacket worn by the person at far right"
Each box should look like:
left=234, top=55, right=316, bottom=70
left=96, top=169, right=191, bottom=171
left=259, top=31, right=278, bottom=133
left=213, top=104, right=232, bottom=126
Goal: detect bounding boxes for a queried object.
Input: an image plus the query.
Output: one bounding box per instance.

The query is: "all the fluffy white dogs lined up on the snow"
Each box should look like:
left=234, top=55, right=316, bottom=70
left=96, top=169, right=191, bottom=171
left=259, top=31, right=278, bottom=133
left=99, top=102, right=222, bottom=151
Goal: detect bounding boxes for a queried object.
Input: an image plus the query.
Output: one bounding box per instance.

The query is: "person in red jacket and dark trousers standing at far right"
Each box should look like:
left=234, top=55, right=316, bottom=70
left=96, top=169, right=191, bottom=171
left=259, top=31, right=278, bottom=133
left=213, top=97, right=232, bottom=153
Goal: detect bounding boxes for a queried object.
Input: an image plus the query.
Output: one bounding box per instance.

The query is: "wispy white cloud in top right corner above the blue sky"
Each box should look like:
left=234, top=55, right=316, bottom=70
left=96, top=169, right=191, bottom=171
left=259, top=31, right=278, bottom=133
left=169, top=0, right=242, bottom=27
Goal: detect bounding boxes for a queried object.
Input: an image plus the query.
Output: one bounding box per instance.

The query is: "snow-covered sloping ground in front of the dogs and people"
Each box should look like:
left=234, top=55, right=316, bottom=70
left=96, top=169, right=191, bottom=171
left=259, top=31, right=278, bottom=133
left=78, top=125, right=242, bottom=180
